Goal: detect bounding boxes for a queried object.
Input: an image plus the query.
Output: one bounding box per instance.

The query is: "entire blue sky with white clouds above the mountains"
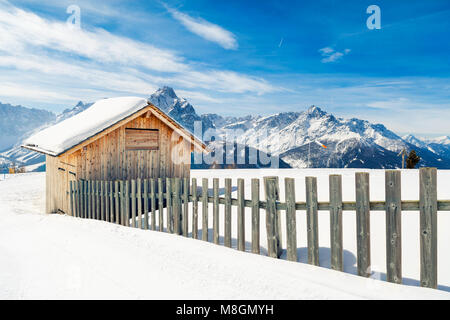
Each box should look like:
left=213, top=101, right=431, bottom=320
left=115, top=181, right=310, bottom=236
left=0, top=0, right=450, bottom=136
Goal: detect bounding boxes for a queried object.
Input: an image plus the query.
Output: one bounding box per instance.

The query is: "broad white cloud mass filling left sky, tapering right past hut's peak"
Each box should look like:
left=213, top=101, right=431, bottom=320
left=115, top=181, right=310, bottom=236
left=0, top=0, right=279, bottom=104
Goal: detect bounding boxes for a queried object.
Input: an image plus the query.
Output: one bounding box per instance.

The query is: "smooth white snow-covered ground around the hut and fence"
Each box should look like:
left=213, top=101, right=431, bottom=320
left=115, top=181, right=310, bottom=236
left=0, top=170, right=450, bottom=299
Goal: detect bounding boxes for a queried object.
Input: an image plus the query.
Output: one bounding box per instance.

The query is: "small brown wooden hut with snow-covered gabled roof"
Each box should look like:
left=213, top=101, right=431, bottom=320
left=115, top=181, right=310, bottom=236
left=22, top=97, right=207, bottom=213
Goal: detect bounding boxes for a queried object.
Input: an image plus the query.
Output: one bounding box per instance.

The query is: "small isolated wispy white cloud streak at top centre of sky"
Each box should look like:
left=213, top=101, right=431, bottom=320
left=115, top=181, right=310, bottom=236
left=165, top=6, right=238, bottom=50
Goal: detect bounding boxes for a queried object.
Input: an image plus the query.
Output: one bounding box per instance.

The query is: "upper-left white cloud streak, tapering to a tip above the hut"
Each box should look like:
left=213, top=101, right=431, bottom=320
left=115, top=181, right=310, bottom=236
left=0, top=6, right=187, bottom=72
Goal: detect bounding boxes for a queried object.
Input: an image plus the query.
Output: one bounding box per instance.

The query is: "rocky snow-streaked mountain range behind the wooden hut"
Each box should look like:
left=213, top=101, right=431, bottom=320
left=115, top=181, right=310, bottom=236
left=0, top=87, right=450, bottom=170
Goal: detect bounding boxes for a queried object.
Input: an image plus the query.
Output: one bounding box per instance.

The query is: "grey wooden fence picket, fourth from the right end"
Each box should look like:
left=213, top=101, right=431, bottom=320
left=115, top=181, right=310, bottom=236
left=329, top=174, right=344, bottom=271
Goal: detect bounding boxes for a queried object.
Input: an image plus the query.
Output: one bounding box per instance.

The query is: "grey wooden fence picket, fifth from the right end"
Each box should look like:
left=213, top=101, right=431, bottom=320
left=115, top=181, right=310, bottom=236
left=305, top=177, right=319, bottom=266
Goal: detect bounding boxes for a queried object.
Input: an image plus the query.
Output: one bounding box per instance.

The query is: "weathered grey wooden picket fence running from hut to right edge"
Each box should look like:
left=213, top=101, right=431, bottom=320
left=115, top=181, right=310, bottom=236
left=70, top=168, right=442, bottom=288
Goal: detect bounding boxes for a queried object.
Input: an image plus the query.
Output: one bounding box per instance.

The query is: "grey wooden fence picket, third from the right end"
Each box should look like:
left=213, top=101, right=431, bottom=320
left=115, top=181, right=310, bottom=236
left=355, top=172, right=371, bottom=278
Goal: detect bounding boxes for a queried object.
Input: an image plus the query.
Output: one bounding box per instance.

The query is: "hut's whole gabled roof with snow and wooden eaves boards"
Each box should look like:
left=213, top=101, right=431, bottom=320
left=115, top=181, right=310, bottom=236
left=21, top=97, right=210, bottom=157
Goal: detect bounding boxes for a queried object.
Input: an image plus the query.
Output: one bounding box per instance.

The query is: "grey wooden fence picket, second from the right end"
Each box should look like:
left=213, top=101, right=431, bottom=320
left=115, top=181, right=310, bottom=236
left=385, top=170, right=402, bottom=283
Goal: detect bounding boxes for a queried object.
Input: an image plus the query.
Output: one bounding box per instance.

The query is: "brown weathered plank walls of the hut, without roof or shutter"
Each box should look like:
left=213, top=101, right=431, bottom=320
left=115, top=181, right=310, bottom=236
left=46, top=114, right=192, bottom=213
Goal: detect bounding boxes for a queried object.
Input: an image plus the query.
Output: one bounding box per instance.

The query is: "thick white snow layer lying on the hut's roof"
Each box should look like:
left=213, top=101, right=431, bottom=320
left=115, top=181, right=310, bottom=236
left=24, top=97, right=148, bottom=155
